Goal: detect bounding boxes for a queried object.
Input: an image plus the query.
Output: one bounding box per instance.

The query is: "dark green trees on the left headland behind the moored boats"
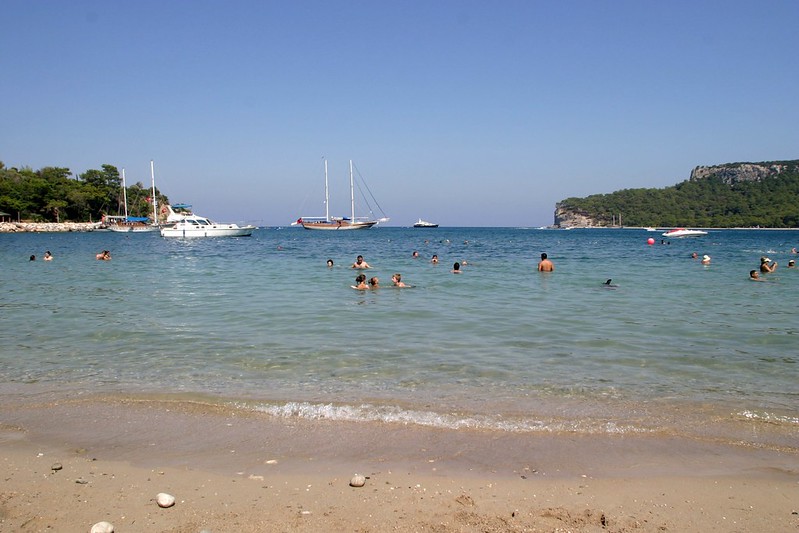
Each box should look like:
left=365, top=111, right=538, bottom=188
left=0, top=161, right=169, bottom=222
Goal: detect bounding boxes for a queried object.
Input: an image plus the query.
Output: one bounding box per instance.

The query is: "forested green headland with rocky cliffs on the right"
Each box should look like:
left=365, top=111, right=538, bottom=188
left=555, top=160, right=799, bottom=228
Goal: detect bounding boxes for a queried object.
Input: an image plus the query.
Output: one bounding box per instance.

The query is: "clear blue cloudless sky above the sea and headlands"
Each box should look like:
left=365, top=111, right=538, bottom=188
left=0, top=0, right=799, bottom=226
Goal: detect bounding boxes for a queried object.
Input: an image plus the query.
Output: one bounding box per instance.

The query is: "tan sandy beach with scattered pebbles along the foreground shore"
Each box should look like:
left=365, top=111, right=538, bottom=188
left=0, top=392, right=799, bottom=533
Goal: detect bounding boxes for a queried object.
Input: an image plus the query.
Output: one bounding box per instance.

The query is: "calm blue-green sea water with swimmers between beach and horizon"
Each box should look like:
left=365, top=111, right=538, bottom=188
left=0, top=227, right=799, bottom=449
